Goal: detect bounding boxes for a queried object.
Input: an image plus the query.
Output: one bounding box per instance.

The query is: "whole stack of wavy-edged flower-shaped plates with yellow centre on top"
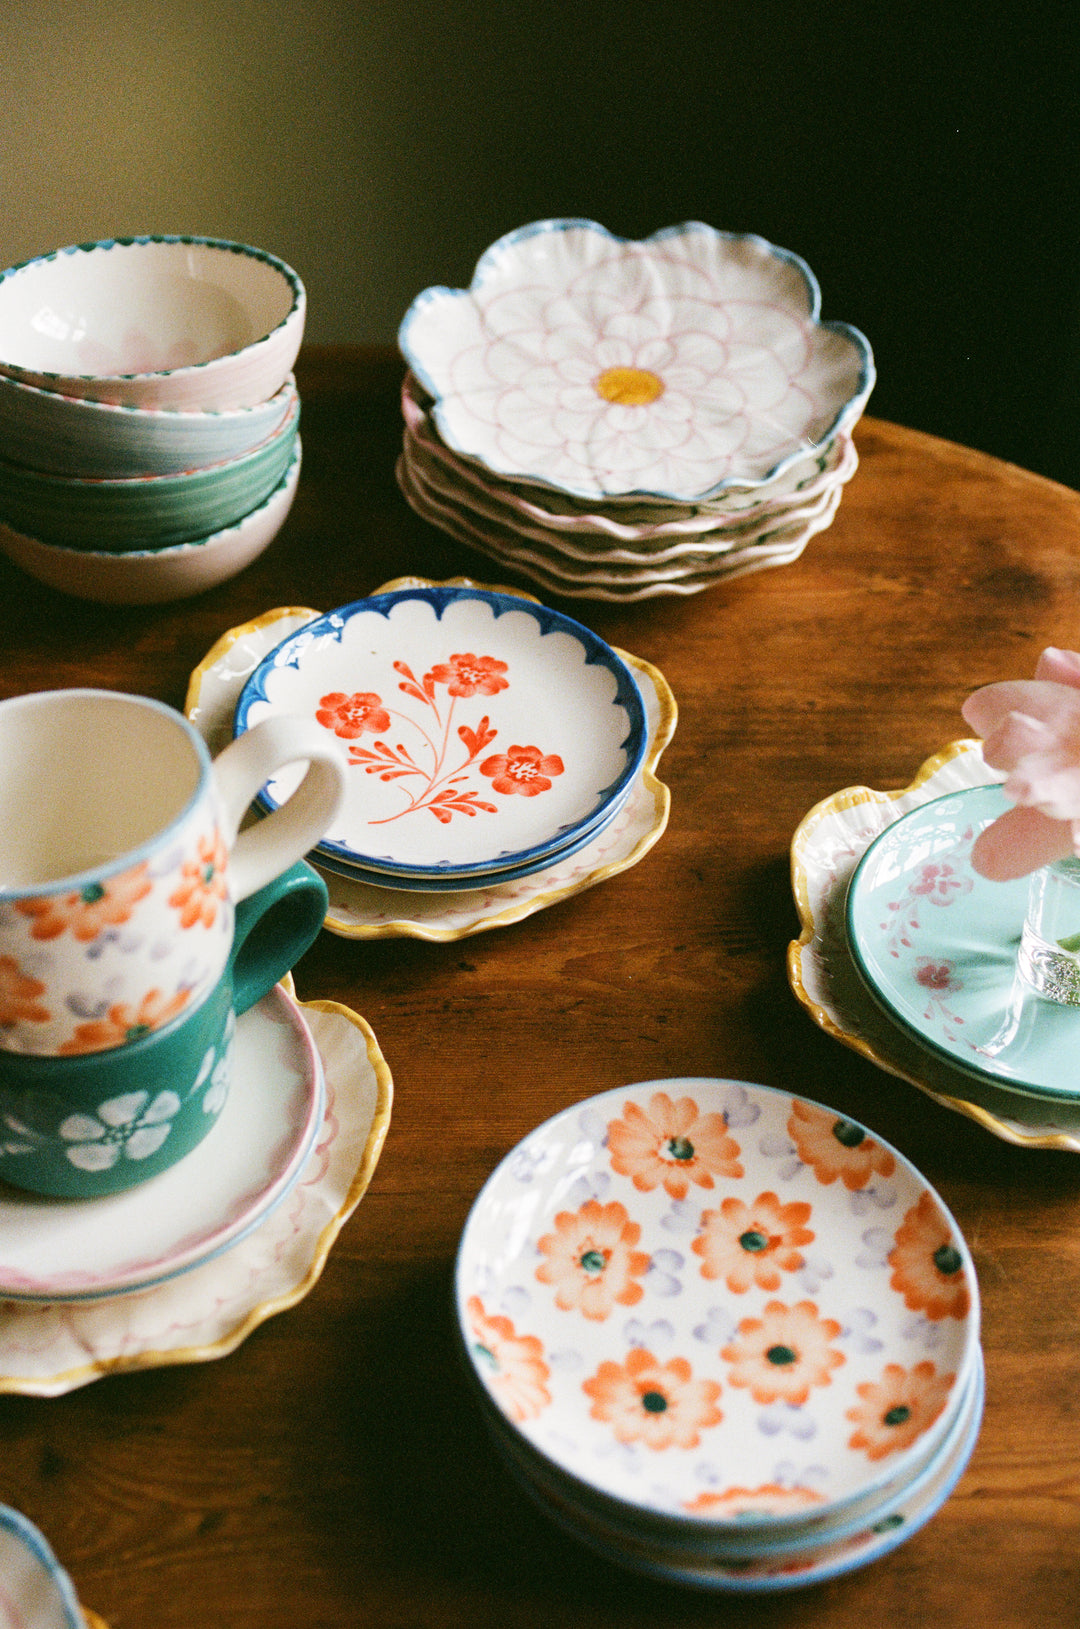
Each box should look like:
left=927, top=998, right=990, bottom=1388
left=397, top=220, right=875, bottom=601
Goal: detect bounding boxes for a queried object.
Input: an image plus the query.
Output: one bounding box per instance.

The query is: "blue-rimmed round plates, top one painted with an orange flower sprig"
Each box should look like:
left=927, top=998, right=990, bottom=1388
left=235, top=583, right=648, bottom=893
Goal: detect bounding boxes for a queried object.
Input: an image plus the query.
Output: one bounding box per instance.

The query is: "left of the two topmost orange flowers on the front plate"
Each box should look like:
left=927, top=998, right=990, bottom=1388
left=608, top=1091, right=743, bottom=1199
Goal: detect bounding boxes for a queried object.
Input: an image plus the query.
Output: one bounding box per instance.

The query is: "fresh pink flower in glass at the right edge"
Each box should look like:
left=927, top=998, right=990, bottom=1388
left=963, top=647, right=1080, bottom=881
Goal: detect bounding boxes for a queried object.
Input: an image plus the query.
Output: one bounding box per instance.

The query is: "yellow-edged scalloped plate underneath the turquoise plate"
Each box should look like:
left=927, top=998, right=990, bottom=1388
left=787, top=740, right=1080, bottom=1153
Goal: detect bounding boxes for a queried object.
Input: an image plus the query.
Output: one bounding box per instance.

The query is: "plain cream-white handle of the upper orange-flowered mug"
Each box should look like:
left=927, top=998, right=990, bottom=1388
left=213, top=715, right=345, bottom=901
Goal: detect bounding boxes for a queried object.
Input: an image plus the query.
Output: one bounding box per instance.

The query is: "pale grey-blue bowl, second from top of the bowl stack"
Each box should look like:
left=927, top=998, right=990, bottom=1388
left=0, top=373, right=296, bottom=477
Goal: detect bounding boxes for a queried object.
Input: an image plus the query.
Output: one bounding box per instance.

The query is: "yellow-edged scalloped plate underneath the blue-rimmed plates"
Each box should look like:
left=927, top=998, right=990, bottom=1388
left=184, top=578, right=678, bottom=942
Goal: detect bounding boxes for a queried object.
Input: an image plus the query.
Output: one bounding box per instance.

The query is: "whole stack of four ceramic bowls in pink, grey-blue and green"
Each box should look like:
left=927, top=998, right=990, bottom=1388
left=0, top=236, right=306, bottom=603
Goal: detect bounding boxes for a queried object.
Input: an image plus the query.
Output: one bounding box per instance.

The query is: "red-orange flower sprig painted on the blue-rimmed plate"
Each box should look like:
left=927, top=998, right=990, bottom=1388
left=316, top=652, right=565, bottom=826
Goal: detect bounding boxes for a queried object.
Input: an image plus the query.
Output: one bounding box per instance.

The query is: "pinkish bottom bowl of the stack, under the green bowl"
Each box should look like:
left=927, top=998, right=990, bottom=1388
left=0, top=437, right=301, bottom=606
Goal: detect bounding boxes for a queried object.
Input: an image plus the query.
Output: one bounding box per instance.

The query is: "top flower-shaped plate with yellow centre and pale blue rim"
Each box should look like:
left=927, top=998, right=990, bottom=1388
left=399, top=220, right=875, bottom=502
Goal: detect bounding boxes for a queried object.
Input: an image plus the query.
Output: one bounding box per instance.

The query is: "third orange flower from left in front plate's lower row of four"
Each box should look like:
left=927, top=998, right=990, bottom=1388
left=720, top=1302, right=844, bottom=1404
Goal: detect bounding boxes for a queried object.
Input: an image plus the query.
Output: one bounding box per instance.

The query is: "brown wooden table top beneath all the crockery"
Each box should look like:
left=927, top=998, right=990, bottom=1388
left=0, top=352, right=1080, bottom=1629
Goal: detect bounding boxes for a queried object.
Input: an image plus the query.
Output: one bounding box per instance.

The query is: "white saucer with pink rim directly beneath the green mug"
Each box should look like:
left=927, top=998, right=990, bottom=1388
left=0, top=986, right=326, bottom=1302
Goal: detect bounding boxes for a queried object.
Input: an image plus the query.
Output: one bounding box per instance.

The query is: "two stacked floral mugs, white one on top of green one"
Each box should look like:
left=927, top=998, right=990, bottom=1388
left=0, top=689, right=344, bottom=1199
